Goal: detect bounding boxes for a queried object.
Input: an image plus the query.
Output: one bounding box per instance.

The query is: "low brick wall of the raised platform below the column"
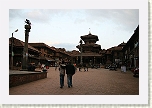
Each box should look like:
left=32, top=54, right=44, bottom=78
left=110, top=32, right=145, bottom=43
left=9, top=72, right=47, bottom=87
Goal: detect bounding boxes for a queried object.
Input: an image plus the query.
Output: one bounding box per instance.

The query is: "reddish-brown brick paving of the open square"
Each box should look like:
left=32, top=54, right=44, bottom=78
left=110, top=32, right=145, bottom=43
left=9, top=67, right=139, bottom=95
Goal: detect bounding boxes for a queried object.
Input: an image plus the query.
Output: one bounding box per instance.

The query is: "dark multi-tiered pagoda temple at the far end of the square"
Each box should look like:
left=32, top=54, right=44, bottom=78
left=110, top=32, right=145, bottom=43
left=75, top=32, right=101, bottom=65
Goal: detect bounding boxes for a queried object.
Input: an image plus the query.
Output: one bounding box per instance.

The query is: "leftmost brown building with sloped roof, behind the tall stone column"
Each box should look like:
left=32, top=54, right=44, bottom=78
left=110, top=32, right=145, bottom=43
left=9, top=37, right=41, bottom=69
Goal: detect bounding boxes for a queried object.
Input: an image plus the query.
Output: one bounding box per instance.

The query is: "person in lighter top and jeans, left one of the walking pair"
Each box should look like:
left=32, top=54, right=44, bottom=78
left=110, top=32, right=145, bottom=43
left=59, top=61, right=66, bottom=88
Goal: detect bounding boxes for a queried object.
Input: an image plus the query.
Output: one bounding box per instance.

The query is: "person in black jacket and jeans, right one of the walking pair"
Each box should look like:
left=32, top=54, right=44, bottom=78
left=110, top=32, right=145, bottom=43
left=66, top=62, right=75, bottom=88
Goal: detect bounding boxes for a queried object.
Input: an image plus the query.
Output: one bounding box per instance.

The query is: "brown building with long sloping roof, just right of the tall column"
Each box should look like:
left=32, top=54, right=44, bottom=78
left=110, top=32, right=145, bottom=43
left=29, top=43, right=71, bottom=66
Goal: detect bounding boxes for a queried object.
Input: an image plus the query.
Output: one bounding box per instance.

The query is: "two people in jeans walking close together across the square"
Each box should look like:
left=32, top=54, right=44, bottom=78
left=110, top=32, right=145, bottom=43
left=59, top=61, right=75, bottom=88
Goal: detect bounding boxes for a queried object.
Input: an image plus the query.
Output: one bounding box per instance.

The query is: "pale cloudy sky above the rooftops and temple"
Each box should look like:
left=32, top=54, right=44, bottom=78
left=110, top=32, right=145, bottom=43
left=9, top=9, right=139, bottom=51
